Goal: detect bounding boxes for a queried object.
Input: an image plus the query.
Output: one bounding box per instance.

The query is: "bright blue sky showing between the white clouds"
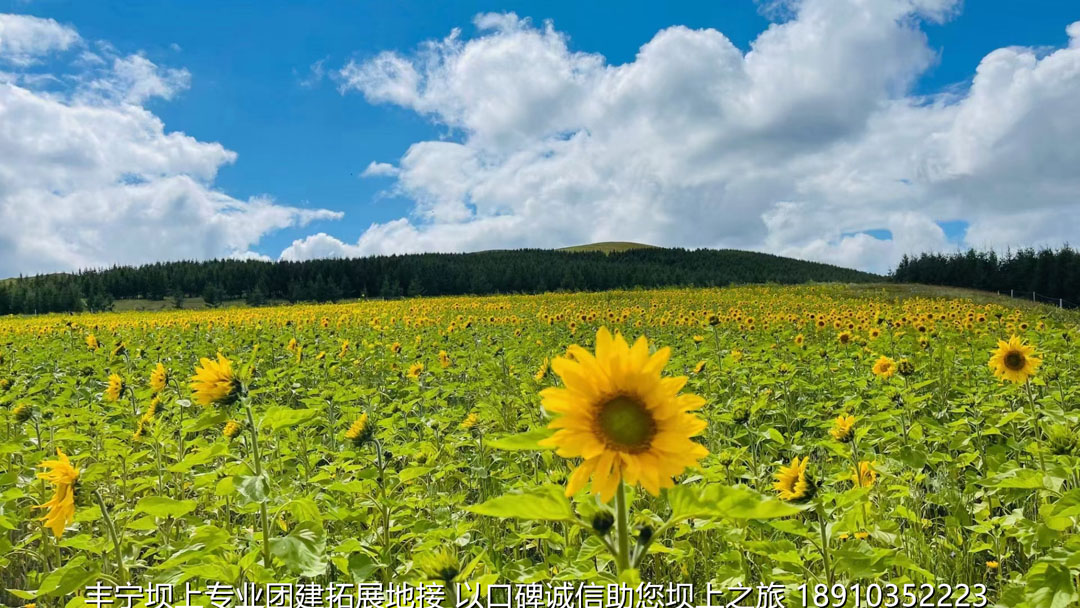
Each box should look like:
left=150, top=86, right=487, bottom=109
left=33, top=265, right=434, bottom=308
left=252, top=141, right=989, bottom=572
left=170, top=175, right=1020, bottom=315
left=8, top=0, right=1080, bottom=274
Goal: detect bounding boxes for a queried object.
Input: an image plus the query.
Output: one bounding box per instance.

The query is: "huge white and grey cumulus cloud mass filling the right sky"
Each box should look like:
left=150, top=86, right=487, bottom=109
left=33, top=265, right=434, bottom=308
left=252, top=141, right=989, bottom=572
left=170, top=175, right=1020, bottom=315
left=317, top=0, right=1080, bottom=271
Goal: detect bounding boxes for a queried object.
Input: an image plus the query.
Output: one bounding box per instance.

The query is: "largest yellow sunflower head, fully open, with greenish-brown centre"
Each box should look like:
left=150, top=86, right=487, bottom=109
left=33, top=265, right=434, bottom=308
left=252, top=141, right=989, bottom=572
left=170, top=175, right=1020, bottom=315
left=540, top=328, right=708, bottom=501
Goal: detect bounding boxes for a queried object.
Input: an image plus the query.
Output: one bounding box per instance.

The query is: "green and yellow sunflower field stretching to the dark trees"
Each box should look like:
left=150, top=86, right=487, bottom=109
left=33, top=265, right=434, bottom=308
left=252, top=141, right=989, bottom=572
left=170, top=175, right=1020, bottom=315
left=0, top=285, right=1080, bottom=607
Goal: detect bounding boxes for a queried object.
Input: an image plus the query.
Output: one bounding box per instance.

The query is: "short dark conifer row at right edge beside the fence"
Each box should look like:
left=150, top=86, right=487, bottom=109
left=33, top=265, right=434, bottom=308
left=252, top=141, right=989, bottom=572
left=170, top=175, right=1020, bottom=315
left=892, top=245, right=1080, bottom=306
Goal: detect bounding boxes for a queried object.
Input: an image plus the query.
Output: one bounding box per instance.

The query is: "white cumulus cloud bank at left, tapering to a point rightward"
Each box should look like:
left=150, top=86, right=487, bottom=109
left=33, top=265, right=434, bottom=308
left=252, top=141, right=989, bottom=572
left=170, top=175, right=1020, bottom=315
left=0, top=15, right=341, bottom=276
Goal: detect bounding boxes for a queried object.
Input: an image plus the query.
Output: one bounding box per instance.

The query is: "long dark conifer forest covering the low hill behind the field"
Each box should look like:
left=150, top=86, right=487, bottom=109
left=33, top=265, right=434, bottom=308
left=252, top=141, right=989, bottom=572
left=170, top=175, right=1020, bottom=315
left=0, top=247, right=881, bottom=314
